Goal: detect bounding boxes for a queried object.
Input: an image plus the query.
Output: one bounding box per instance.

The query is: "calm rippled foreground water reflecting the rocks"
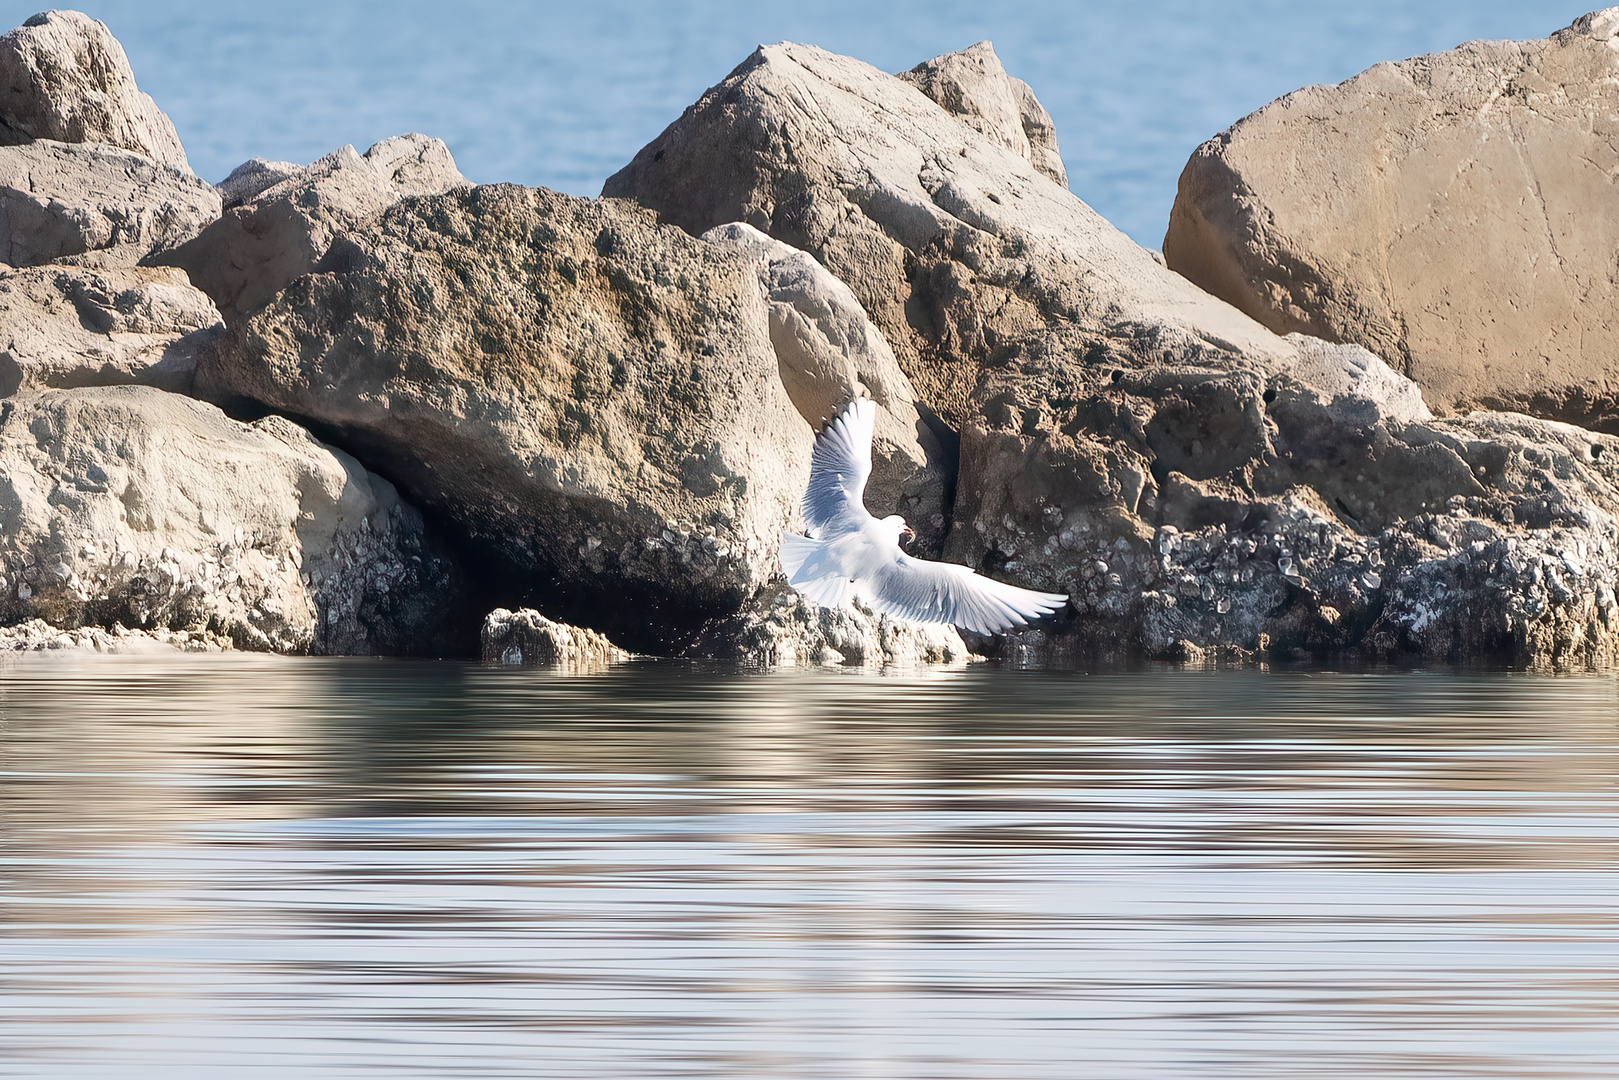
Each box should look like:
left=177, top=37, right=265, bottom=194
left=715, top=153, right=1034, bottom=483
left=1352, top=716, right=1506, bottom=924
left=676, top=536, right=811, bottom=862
left=0, top=657, right=1619, bottom=1080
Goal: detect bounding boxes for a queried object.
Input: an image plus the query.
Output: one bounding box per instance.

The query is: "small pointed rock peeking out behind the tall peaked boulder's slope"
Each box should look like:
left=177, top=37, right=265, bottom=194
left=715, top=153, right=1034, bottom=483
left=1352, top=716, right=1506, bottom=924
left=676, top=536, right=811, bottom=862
left=899, top=40, right=1069, bottom=188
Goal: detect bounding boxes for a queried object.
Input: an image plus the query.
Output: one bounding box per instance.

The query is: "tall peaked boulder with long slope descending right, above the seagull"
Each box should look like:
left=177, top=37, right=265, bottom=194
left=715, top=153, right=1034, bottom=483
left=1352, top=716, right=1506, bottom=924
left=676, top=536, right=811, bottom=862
left=602, top=44, right=1294, bottom=427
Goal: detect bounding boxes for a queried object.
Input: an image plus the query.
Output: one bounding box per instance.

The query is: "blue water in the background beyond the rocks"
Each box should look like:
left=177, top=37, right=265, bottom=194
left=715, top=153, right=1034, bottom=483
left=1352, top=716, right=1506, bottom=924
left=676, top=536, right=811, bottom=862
left=0, top=0, right=1588, bottom=248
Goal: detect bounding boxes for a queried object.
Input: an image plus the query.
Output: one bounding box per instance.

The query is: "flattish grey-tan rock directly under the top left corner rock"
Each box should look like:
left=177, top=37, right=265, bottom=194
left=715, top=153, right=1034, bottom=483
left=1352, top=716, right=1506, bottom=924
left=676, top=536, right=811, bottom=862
left=0, top=139, right=220, bottom=267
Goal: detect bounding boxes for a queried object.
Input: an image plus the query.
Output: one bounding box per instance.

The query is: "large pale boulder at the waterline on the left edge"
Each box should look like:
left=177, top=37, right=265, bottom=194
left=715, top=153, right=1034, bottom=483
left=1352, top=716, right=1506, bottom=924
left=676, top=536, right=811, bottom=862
left=0, top=387, right=476, bottom=654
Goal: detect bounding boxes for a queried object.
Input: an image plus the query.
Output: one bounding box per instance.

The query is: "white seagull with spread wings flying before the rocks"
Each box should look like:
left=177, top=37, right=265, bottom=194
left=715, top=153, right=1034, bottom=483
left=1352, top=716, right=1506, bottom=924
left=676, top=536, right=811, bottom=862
left=782, top=397, right=1069, bottom=633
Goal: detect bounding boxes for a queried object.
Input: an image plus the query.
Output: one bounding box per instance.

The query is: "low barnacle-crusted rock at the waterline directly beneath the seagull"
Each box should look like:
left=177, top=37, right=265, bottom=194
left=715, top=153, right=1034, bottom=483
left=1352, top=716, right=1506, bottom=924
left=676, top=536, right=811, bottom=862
left=686, top=585, right=975, bottom=667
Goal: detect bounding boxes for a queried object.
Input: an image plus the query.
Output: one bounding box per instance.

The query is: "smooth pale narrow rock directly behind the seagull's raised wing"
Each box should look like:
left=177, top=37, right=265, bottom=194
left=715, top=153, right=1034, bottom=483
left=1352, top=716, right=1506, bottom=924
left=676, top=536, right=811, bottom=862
left=703, top=222, right=955, bottom=555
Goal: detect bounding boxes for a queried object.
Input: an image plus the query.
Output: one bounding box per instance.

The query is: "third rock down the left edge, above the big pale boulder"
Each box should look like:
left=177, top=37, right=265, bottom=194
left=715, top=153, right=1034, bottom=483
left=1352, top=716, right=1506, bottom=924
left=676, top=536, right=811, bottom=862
left=0, top=266, right=225, bottom=397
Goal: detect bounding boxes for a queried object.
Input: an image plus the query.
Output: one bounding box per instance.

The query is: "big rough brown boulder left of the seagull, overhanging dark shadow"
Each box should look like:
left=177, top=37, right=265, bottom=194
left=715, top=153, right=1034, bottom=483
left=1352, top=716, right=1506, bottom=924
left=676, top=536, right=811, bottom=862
left=198, top=185, right=813, bottom=651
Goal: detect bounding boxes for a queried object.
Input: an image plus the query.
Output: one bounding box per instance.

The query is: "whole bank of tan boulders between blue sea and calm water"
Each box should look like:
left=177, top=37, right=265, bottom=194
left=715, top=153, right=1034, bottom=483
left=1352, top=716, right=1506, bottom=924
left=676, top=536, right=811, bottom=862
left=0, top=8, right=1619, bottom=667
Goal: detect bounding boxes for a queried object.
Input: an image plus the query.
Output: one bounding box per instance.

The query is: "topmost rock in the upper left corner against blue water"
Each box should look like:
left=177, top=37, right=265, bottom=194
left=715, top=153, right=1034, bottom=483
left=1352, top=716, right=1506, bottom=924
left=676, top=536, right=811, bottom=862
left=0, top=11, right=191, bottom=173
